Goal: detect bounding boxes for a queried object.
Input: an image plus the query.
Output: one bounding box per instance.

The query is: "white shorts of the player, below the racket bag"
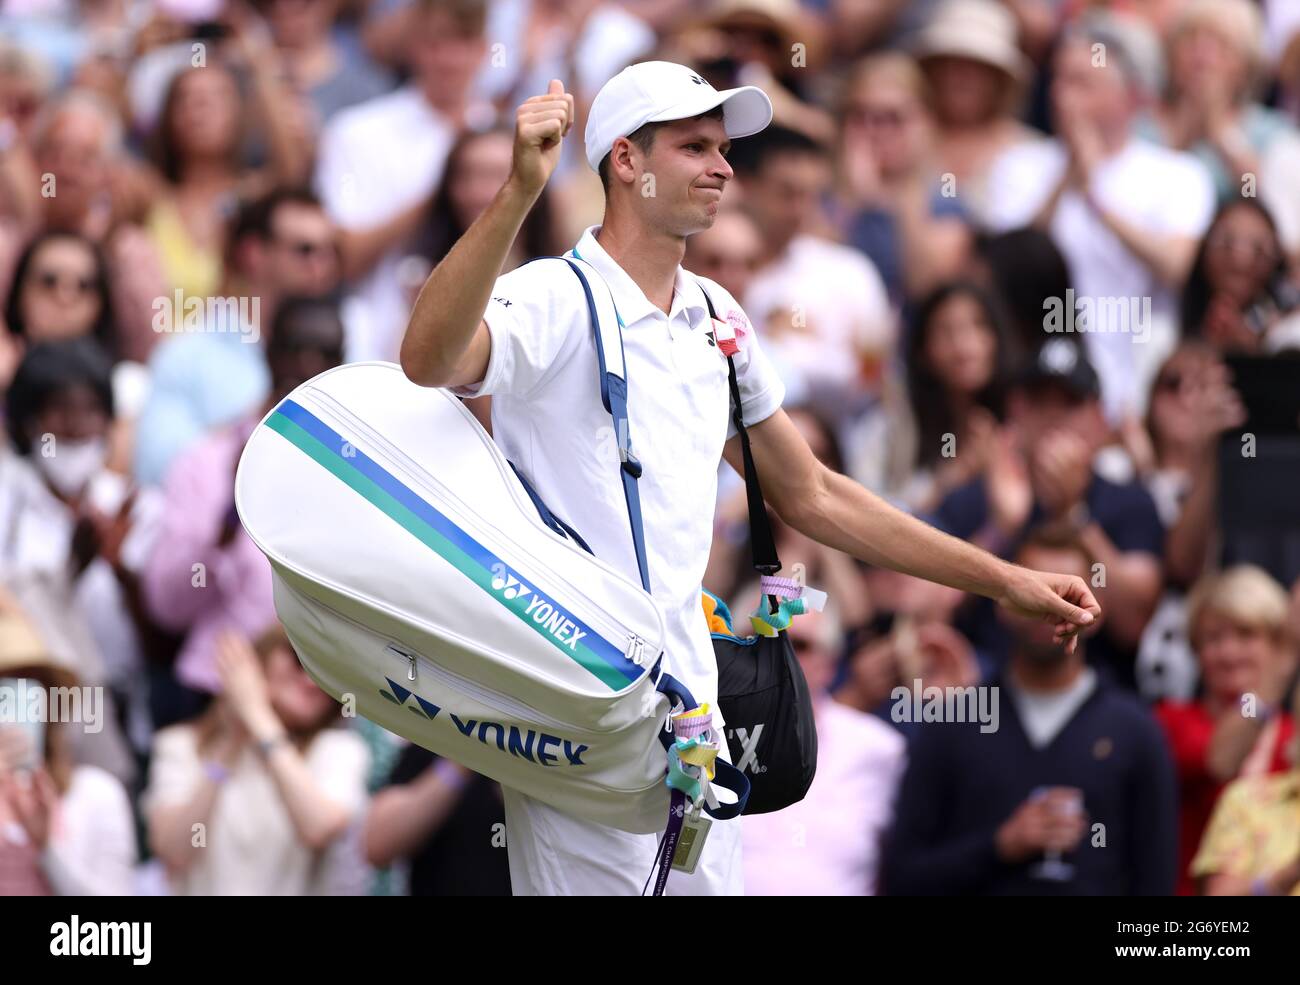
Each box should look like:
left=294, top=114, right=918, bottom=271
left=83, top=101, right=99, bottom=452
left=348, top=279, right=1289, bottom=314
left=504, top=789, right=745, bottom=897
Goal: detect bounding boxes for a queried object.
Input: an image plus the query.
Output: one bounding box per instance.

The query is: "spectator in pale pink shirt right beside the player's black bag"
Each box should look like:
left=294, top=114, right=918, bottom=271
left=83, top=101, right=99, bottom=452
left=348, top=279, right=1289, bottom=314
left=741, top=609, right=905, bottom=897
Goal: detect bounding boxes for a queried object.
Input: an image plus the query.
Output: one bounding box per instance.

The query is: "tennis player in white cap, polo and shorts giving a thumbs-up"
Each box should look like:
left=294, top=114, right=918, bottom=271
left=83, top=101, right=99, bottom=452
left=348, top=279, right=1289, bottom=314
left=402, top=62, right=1100, bottom=895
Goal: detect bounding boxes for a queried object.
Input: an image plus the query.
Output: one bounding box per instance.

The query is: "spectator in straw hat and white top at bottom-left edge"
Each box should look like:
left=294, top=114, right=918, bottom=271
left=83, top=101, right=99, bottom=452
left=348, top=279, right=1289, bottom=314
left=0, top=593, right=135, bottom=897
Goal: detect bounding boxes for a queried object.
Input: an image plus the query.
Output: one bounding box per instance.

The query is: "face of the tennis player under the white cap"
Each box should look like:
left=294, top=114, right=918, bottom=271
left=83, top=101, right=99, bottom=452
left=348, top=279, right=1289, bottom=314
left=636, top=118, right=733, bottom=237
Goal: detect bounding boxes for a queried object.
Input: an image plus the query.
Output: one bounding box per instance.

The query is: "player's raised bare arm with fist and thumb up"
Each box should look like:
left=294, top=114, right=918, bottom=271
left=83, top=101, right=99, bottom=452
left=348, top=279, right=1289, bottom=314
left=400, top=79, right=573, bottom=386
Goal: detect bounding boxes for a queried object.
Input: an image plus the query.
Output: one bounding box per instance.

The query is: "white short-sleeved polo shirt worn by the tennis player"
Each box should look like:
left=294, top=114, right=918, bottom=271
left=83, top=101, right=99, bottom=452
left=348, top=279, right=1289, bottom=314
left=452, top=226, right=785, bottom=726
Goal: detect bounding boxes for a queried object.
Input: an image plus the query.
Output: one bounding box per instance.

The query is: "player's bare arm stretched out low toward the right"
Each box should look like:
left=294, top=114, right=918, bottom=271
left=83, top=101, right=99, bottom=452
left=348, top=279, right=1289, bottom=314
left=724, top=409, right=1101, bottom=650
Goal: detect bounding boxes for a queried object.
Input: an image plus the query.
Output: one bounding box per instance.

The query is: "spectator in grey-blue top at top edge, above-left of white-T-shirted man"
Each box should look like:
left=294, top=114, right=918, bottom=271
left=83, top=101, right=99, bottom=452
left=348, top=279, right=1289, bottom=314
left=257, top=0, right=391, bottom=130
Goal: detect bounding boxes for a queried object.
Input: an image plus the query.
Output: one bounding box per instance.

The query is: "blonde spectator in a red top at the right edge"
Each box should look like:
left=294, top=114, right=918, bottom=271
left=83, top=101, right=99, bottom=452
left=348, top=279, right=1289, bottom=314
left=1156, top=565, right=1295, bottom=895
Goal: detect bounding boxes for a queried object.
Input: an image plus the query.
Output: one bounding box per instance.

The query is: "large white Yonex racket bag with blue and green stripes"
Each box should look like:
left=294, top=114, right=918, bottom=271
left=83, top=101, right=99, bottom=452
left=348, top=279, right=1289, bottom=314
left=235, top=363, right=689, bottom=833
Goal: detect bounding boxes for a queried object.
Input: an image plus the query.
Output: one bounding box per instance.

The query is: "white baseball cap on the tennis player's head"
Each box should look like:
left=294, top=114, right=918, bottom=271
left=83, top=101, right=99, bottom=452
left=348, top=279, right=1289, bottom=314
left=586, top=61, right=772, bottom=172
